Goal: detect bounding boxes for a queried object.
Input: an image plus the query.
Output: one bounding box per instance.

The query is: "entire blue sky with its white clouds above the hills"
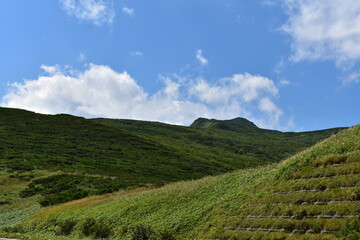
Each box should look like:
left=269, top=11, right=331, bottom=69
left=0, top=0, right=360, bottom=131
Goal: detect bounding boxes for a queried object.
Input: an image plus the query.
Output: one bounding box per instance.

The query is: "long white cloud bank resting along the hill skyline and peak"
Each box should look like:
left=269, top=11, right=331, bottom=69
left=1, top=64, right=282, bottom=127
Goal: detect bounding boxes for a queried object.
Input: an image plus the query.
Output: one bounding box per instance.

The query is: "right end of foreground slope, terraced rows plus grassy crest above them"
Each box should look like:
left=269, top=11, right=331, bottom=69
left=208, top=126, right=360, bottom=239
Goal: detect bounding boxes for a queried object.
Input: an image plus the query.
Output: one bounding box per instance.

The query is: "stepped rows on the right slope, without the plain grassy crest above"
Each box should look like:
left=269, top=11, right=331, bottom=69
left=218, top=157, right=360, bottom=239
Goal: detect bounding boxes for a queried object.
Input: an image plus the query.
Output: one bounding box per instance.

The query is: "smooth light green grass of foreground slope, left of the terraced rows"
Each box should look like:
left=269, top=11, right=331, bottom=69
left=4, top=166, right=272, bottom=239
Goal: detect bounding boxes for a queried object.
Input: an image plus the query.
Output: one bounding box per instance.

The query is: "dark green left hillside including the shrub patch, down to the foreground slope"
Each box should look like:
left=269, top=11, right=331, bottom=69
left=0, top=108, right=266, bottom=210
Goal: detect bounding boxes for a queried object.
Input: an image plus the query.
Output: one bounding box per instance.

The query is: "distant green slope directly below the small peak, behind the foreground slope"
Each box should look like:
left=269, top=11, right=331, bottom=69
left=93, top=119, right=341, bottom=164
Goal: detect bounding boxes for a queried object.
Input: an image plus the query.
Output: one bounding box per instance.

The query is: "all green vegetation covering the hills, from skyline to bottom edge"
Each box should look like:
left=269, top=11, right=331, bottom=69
left=0, top=108, right=360, bottom=239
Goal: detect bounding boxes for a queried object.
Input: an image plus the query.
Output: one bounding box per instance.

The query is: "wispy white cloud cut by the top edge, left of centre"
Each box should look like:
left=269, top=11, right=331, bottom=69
left=59, top=0, right=115, bottom=25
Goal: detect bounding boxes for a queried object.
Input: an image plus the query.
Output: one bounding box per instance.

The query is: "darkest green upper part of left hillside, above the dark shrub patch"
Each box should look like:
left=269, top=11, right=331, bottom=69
left=0, top=108, right=211, bottom=181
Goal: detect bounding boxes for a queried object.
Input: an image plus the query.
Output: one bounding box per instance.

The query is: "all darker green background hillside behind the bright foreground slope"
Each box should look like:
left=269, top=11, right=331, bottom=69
left=0, top=108, right=340, bottom=210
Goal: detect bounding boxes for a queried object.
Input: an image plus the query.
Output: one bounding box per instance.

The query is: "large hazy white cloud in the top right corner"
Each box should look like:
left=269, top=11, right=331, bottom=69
left=282, top=0, right=360, bottom=65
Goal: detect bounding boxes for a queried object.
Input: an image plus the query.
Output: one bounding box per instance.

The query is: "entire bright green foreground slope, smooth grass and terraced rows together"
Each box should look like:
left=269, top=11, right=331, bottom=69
left=7, top=125, right=360, bottom=240
